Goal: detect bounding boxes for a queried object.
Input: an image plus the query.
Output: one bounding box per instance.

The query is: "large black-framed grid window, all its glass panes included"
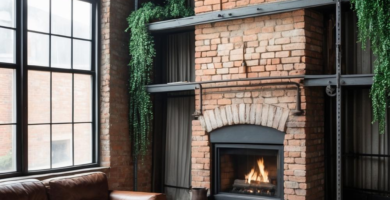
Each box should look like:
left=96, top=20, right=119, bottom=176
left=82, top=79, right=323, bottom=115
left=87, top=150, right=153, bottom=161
left=0, top=0, right=97, bottom=176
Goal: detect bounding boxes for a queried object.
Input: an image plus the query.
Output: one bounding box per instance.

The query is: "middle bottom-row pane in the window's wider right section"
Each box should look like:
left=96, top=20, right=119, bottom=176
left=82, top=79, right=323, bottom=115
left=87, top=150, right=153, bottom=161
left=51, top=124, right=73, bottom=168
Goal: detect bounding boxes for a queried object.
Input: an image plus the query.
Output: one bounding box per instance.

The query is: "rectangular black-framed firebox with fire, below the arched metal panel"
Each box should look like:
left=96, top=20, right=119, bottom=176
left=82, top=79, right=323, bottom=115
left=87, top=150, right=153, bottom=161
left=213, top=144, right=283, bottom=200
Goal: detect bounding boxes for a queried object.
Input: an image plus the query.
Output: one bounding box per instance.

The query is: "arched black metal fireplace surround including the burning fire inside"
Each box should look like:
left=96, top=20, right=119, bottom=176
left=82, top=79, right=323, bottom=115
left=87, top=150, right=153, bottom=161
left=210, top=125, right=284, bottom=200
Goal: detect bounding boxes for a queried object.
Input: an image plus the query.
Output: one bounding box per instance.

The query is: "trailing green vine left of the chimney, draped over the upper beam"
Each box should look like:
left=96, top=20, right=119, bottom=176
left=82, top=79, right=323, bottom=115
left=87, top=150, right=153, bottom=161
left=126, top=0, right=193, bottom=157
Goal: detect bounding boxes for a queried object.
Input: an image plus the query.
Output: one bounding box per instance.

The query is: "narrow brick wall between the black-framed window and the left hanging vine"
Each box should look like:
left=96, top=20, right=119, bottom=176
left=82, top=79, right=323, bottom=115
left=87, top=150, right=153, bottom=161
left=100, top=0, right=152, bottom=191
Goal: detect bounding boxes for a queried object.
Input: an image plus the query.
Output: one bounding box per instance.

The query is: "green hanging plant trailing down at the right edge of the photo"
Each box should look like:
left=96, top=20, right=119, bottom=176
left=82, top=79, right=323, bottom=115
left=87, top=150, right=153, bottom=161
left=351, top=0, right=390, bottom=134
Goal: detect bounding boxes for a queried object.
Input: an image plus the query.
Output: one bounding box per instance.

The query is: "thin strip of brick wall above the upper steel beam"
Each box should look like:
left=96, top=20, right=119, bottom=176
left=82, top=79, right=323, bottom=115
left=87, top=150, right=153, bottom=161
left=195, top=0, right=288, bottom=14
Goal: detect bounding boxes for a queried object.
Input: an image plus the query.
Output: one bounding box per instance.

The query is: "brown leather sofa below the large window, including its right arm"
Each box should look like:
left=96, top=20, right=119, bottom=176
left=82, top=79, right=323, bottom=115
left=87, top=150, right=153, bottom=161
left=0, top=172, right=166, bottom=200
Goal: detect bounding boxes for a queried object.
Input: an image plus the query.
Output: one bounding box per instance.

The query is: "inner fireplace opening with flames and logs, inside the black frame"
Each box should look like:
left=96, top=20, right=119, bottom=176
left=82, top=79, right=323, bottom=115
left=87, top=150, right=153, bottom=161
left=220, top=148, right=278, bottom=196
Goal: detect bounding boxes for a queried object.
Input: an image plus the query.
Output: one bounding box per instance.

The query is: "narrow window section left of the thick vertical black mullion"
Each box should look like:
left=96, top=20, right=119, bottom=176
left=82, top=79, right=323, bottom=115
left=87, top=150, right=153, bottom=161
left=0, top=0, right=17, bottom=173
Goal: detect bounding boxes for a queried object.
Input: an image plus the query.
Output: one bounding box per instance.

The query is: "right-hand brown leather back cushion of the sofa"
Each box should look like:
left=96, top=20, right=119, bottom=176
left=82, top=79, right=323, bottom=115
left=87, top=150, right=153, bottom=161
left=42, top=172, right=109, bottom=200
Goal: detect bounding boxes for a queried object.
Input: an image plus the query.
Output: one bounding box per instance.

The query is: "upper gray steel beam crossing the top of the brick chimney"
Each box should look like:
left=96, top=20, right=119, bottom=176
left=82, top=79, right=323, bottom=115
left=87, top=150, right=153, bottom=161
left=148, top=0, right=349, bottom=32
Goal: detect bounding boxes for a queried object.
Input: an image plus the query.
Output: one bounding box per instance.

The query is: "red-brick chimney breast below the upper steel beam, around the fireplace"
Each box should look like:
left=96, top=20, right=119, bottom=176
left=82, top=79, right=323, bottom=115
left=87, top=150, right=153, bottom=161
left=192, top=10, right=324, bottom=200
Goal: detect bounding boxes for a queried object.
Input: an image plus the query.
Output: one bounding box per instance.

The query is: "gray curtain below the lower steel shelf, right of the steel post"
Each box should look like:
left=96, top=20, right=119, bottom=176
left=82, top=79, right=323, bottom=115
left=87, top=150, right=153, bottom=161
left=344, top=89, right=390, bottom=191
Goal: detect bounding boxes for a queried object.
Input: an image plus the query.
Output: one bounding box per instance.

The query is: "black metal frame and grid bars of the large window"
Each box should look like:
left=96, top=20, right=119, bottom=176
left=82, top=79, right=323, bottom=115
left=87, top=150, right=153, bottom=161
left=0, top=0, right=101, bottom=179
